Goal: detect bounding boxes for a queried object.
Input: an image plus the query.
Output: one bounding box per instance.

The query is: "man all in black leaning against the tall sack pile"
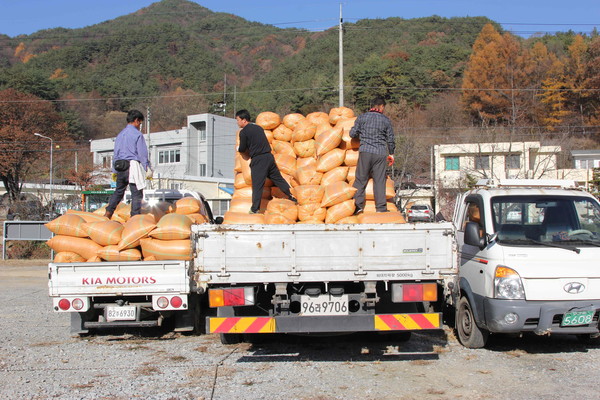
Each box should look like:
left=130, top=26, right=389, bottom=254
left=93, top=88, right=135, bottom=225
left=235, top=110, right=296, bottom=214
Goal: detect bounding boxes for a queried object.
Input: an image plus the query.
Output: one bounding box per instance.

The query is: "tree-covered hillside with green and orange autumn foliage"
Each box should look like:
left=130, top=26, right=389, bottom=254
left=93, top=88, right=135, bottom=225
left=0, top=0, right=600, bottom=205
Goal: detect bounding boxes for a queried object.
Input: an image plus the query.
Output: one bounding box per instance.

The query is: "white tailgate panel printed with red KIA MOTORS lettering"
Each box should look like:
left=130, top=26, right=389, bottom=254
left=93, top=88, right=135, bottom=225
left=48, top=261, right=190, bottom=296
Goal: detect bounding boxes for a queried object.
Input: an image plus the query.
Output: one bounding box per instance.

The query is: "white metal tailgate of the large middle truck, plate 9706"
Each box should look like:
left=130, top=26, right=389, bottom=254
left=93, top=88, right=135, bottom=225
left=194, top=223, right=456, bottom=283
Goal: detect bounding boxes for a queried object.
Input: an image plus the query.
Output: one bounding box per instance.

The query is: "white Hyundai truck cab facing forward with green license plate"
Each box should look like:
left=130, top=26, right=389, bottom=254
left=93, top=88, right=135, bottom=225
left=453, top=180, right=600, bottom=348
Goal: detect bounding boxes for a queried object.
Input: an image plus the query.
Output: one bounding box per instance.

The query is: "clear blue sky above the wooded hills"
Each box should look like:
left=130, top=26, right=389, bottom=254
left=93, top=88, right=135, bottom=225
left=0, top=0, right=600, bottom=37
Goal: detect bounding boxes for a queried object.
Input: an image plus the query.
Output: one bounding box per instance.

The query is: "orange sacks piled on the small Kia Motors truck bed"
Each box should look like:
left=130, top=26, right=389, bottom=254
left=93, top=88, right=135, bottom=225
left=46, top=197, right=207, bottom=262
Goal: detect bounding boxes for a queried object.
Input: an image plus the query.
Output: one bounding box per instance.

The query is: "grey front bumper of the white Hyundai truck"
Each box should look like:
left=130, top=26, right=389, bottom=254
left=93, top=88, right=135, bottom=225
left=483, top=298, right=600, bottom=335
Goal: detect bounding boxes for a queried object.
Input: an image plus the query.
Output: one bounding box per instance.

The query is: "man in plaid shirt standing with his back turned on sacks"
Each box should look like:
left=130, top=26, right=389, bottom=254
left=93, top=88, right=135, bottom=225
left=350, top=97, right=396, bottom=215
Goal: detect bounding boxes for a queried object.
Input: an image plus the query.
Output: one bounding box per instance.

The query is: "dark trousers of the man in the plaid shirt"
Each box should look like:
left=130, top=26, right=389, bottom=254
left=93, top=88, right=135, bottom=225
left=352, top=152, right=387, bottom=212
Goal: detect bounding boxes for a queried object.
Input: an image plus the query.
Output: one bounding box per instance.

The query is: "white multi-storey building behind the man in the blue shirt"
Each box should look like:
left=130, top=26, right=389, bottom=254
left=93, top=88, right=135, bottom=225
left=90, top=114, right=238, bottom=215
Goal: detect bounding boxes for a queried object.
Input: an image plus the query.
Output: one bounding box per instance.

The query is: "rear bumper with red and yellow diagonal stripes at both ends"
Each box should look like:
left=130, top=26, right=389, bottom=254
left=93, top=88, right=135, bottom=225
left=206, top=313, right=442, bottom=333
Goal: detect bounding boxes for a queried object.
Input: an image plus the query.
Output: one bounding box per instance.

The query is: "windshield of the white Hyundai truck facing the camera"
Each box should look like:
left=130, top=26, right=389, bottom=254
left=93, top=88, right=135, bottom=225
left=492, top=196, right=600, bottom=247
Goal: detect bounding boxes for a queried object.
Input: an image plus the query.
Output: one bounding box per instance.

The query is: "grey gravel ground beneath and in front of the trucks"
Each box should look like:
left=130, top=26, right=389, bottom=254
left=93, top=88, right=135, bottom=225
left=0, top=262, right=600, bottom=400
